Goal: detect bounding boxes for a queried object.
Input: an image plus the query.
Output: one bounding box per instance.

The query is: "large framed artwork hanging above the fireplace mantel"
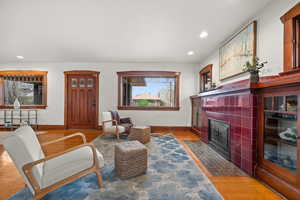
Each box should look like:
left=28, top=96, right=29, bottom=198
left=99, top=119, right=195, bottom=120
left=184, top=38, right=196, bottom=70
left=220, top=21, right=257, bottom=80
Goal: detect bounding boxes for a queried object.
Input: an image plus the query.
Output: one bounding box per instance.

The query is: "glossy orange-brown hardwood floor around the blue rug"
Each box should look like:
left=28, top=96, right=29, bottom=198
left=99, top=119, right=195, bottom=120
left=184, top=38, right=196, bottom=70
left=0, top=130, right=282, bottom=200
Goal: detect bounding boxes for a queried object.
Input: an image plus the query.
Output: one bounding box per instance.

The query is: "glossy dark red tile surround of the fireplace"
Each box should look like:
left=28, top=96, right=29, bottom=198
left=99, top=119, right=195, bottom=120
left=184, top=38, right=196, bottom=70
left=195, top=89, right=257, bottom=175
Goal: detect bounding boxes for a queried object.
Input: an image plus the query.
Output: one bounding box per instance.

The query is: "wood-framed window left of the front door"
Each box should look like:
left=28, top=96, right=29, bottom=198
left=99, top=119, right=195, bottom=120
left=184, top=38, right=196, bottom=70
left=0, top=71, right=47, bottom=108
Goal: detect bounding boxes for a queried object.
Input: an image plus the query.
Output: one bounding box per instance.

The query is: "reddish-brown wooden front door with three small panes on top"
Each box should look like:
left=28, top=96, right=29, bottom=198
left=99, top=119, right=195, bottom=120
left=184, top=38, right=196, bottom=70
left=65, top=71, right=99, bottom=129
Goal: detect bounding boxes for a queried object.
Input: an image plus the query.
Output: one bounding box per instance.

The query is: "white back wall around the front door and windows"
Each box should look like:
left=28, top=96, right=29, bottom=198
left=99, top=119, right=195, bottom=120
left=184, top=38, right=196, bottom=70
left=0, top=63, right=196, bottom=126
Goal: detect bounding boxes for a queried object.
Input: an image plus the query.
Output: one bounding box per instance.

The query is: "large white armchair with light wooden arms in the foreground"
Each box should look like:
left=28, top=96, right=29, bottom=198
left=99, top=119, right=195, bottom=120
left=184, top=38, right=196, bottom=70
left=4, top=126, right=104, bottom=200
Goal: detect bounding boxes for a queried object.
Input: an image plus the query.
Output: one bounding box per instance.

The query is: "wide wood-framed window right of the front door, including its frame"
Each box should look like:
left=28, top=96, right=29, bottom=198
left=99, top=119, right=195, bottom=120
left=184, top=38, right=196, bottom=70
left=118, top=71, right=180, bottom=110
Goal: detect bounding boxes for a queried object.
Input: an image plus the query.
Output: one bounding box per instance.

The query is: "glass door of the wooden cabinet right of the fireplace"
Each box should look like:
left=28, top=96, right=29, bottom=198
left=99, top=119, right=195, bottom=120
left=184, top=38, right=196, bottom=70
left=262, top=95, right=299, bottom=174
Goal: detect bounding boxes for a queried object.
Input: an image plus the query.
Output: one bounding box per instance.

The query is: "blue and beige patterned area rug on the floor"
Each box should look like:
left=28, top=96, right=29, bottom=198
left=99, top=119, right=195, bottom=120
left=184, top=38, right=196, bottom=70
left=9, top=135, right=223, bottom=200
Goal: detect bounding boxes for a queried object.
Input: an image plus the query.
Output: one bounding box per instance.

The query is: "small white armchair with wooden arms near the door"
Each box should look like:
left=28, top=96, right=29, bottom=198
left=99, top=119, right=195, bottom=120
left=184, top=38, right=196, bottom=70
left=102, top=112, right=125, bottom=140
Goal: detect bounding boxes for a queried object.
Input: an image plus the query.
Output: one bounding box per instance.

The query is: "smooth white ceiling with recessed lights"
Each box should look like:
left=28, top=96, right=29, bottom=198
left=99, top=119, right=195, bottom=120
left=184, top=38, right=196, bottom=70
left=0, top=0, right=271, bottom=63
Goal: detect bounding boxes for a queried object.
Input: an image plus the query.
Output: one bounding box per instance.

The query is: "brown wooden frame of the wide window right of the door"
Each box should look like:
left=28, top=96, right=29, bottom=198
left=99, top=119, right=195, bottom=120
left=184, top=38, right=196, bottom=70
left=117, top=71, right=181, bottom=111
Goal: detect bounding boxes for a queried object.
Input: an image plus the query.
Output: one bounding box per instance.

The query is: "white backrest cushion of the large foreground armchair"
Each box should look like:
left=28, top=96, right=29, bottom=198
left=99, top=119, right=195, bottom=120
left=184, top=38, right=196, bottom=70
left=3, top=126, right=45, bottom=193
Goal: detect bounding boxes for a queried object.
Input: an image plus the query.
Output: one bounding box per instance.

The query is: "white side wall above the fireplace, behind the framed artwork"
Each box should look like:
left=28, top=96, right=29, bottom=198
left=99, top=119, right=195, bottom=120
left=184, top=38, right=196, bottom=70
left=196, top=0, right=299, bottom=89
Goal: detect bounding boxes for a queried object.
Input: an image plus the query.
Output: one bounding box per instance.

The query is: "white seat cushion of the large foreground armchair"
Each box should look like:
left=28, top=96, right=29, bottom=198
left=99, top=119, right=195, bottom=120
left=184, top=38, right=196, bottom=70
left=42, top=147, right=104, bottom=188
